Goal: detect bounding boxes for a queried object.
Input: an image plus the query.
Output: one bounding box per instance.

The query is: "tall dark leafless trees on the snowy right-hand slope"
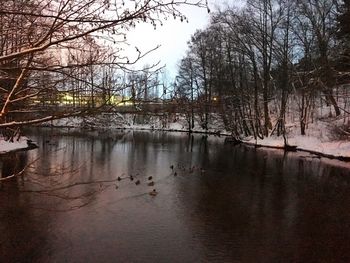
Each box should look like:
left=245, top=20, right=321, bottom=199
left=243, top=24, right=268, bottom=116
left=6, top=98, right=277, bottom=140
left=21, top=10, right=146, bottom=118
left=176, top=0, right=350, bottom=138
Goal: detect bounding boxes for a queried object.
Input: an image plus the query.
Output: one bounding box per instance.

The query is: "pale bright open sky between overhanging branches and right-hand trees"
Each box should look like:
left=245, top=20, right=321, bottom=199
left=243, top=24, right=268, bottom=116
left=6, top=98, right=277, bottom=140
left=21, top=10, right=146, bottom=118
left=128, top=0, right=224, bottom=78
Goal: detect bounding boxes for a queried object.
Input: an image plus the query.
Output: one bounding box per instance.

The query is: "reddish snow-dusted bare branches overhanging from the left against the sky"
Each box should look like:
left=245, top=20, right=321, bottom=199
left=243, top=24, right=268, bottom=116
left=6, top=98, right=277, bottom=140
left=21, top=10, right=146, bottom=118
left=0, top=0, right=207, bottom=135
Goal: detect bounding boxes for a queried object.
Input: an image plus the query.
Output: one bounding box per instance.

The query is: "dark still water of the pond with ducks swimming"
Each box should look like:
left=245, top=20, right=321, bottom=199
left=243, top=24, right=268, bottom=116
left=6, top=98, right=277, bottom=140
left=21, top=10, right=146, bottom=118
left=0, top=130, right=350, bottom=262
